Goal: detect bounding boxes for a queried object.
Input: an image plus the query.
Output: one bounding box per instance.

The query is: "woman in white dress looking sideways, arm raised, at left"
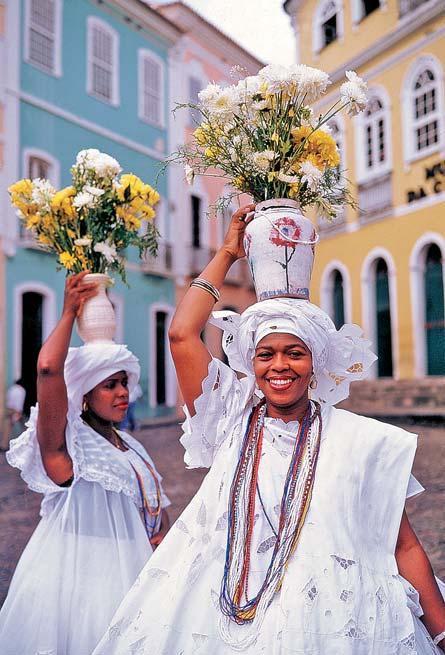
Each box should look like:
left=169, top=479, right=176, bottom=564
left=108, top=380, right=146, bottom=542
left=0, top=273, right=169, bottom=655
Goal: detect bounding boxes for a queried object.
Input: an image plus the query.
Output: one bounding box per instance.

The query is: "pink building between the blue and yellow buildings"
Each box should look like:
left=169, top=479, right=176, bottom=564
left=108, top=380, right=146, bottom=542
left=157, top=2, right=262, bottom=354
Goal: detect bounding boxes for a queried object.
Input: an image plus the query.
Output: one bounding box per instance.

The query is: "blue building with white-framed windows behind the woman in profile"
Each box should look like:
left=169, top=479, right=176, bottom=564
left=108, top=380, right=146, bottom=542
left=2, top=0, right=181, bottom=417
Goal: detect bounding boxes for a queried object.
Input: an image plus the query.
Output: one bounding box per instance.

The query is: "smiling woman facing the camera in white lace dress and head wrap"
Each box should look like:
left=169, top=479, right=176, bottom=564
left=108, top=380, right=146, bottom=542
left=94, top=206, right=445, bottom=655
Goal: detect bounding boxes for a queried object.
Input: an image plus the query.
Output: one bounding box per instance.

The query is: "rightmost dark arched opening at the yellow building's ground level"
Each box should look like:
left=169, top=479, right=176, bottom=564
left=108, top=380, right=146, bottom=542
left=424, top=244, right=445, bottom=375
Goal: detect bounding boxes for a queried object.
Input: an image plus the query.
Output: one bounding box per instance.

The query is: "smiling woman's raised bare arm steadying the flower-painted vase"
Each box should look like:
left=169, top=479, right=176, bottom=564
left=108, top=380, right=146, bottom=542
left=169, top=205, right=255, bottom=416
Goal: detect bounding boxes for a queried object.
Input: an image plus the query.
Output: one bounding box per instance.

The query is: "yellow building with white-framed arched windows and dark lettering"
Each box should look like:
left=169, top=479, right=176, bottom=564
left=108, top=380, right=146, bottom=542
left=284, top=0, right=445, bottom=411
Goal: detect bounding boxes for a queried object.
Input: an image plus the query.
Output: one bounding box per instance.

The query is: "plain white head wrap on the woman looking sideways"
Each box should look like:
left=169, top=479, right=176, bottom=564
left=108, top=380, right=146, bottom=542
left=65, top=343, right=141, bottom=413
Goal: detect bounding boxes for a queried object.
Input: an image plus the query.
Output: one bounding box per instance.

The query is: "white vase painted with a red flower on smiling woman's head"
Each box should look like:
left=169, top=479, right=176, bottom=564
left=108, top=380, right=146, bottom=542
left=244, top=198, right=318, bottom=300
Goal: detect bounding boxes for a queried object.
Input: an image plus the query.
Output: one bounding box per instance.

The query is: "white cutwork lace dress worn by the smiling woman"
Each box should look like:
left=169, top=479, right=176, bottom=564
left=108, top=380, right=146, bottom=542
left=94, top=361, right=439, bottom=655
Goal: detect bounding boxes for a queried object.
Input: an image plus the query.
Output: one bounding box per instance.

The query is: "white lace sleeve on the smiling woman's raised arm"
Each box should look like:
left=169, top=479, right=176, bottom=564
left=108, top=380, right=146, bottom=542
left=181, top=359, right=249, bottom=468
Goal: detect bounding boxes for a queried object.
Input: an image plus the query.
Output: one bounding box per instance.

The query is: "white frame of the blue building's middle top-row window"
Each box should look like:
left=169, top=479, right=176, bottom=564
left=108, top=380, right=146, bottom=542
left=86, top=16, right=120, bottom=107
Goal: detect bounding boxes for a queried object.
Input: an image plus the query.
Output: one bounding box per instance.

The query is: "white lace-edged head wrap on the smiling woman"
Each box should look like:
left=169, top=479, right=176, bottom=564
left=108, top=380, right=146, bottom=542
left=210, top=298, right=377, bottom=405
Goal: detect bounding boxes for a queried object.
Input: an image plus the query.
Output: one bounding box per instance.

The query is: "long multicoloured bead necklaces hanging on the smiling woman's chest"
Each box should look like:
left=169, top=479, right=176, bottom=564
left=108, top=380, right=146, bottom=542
left=220, top=401, right=322, bottom=649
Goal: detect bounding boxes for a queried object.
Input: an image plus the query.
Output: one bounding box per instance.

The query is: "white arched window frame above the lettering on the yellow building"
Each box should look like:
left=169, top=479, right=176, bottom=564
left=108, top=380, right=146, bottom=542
left=401, top=55, right=445, bottom=164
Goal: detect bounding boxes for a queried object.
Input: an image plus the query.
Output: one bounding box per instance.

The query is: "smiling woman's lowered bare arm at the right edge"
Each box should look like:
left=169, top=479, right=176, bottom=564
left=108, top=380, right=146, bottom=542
left=396, top=512, right=445, bottom=650
